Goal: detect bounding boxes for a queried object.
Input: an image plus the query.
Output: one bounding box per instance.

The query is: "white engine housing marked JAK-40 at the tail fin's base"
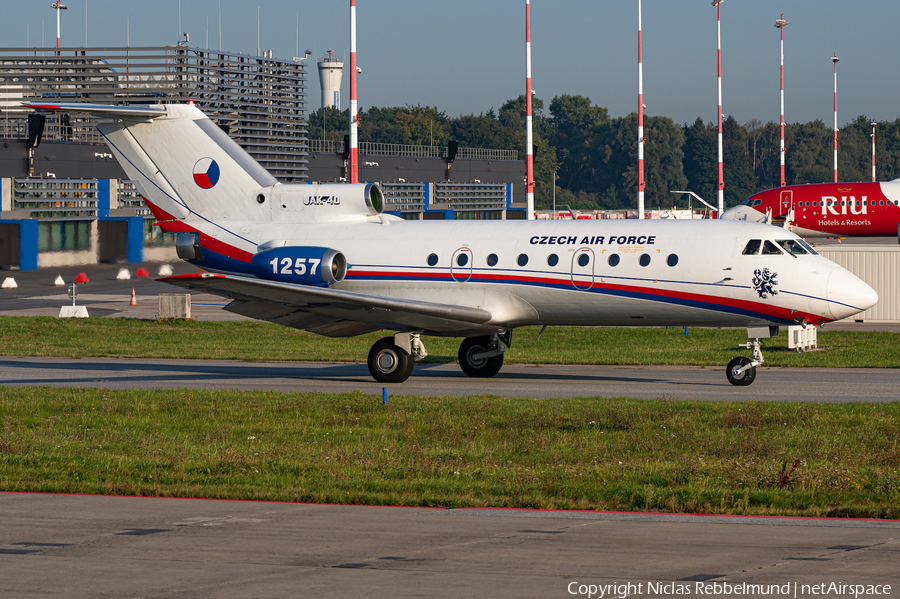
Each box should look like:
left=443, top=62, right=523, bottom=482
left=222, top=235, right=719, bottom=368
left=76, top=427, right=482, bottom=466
left=272, top=183, right=384, bottom=223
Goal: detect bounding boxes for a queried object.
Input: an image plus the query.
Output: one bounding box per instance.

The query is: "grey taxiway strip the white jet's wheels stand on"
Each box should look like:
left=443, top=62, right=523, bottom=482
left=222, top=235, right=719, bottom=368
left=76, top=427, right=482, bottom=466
left=0, top=357, right=900, bottom=402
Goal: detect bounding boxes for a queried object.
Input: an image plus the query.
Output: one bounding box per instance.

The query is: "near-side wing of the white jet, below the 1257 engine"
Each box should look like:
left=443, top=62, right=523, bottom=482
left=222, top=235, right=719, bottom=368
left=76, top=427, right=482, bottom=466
left=158, top=273, right=491, bottom=337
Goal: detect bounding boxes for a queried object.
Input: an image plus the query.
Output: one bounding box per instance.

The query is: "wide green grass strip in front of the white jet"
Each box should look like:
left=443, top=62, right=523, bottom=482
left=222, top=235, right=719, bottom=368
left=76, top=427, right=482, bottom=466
left=0, top=388, right=900, bottom=518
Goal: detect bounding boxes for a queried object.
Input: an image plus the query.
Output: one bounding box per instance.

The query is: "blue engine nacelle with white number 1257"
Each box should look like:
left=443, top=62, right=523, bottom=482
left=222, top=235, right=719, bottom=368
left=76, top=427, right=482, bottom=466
left=250, top=246, right=347, bottom=287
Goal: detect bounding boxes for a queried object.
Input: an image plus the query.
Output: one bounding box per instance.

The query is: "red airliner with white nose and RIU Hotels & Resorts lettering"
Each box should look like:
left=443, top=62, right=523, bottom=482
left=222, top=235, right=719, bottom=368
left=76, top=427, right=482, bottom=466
left=722, top=179, right=900, bottom=244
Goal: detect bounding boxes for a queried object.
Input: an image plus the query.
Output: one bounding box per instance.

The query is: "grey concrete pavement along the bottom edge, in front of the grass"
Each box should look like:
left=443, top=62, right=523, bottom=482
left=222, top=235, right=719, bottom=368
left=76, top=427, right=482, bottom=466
left=0, top=494, right=900, bottom=599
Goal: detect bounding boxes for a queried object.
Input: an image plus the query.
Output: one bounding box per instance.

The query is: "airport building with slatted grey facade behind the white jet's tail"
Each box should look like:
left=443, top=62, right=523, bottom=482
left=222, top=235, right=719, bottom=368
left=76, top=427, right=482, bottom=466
left=0, top=45, right=525, bottom=270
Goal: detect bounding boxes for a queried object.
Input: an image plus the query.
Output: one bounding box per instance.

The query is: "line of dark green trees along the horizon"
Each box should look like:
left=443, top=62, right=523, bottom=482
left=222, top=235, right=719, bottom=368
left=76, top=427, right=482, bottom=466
left=308, top=95, right=900, bottom=210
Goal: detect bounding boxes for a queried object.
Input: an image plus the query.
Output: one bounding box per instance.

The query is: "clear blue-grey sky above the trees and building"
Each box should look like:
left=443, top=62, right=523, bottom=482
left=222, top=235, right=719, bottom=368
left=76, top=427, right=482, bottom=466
left=0, top=0, right=900, bottom=125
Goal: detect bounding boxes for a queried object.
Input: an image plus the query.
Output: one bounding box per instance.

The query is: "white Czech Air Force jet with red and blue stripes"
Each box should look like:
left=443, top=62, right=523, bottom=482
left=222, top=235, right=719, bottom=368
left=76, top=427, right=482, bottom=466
left=27, top=104, right=878, bottom=385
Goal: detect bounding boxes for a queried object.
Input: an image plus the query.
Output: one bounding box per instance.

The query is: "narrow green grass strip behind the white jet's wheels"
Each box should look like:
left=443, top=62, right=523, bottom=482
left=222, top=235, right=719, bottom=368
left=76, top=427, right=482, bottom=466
left=0, top=316, right=900, bottom=368
